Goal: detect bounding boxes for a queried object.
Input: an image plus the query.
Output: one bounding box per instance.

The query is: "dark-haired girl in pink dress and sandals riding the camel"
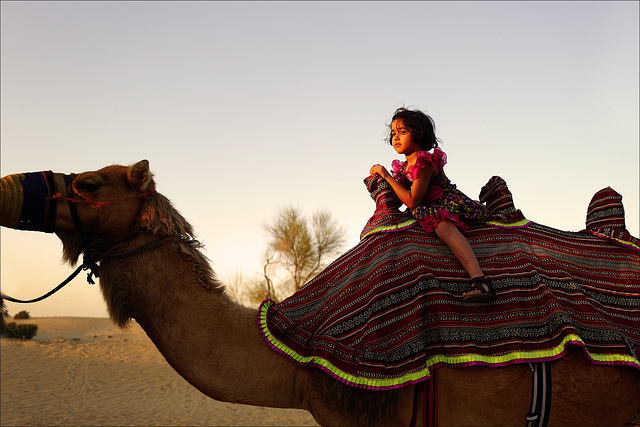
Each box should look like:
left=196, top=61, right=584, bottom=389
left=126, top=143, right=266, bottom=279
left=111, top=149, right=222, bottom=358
left=370, top=108, right=495, bottom=302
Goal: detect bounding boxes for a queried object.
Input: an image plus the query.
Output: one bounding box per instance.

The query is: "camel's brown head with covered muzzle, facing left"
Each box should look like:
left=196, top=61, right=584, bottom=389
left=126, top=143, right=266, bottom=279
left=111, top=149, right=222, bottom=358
left=0, top=160, right=191, bottom=264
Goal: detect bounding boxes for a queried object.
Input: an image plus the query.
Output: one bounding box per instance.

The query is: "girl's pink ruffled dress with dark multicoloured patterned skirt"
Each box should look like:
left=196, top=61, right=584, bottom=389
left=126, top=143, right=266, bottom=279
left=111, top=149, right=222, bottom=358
left=391, top=147, right=487, bottom=232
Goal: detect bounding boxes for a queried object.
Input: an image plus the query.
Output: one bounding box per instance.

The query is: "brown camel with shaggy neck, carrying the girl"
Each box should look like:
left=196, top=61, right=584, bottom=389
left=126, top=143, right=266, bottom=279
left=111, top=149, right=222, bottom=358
left=0, top=160, right=640, bottom=426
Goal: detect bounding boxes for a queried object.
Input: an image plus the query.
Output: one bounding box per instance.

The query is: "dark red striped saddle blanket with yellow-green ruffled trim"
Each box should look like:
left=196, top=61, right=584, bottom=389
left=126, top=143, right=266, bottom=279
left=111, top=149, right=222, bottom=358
left=259, top=177, right=640, bottom=390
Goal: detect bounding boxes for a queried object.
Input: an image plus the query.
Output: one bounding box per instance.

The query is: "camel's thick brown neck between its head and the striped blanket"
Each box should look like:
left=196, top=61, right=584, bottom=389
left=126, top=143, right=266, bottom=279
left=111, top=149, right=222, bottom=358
left=100, top=241, right=299, bottom=408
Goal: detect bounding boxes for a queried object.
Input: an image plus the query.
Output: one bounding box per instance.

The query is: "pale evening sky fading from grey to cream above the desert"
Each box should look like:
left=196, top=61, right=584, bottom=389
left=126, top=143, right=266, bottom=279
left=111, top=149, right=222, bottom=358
left=0, top=1, right=640, bottom=317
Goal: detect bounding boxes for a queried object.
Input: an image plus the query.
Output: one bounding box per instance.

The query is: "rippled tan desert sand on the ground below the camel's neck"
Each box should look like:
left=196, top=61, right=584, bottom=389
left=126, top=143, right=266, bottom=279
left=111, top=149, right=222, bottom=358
left=0, top=317, right=317, bottom=426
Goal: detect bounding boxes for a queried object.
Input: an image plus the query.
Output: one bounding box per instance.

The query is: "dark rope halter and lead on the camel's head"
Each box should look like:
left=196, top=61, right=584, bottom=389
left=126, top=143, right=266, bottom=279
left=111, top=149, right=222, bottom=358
left=0, top=175, right=165, bottom=304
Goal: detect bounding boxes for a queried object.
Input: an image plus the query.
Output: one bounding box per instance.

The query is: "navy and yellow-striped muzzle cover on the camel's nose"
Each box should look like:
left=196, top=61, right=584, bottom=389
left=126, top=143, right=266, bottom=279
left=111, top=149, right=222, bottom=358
left=0, top=171, right=56, bottom=233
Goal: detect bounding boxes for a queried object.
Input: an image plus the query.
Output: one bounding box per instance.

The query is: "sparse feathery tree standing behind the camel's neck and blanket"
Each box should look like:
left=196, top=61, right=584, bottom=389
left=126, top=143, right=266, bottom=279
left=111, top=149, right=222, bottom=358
left=261, top=206, right=345, bottom=299
